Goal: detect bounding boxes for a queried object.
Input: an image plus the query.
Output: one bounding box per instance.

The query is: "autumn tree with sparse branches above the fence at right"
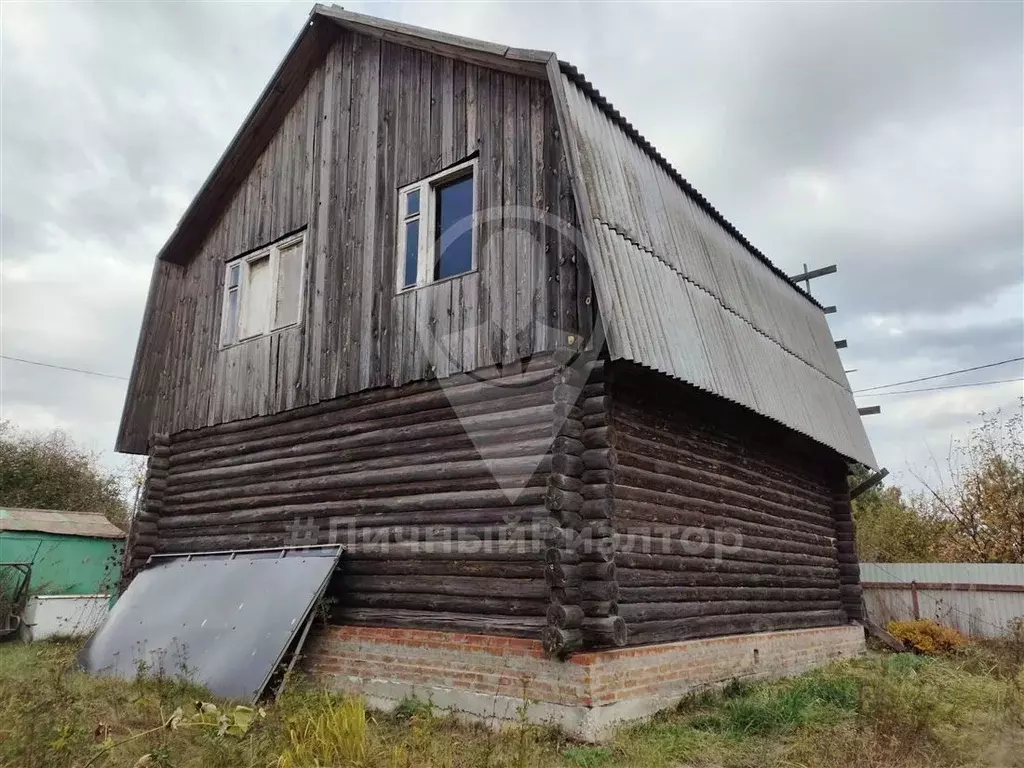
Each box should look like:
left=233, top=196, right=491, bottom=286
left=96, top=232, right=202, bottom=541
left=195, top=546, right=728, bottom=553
left=915, top=398, right=1024, bottom=563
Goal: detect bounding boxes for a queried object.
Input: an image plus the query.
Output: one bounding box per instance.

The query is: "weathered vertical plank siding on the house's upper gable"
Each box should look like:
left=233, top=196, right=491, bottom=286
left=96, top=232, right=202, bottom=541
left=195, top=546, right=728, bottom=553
left=121, top=32, right=577, bottom=452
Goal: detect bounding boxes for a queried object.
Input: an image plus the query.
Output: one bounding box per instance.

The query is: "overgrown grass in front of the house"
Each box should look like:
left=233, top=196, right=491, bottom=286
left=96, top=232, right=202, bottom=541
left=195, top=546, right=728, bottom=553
left=0, top=643, right=1024, bottom=768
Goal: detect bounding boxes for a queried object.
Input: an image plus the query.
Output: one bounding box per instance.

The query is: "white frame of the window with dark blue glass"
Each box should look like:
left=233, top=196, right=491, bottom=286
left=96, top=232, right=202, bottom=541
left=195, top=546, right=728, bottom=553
left=395, top=158, right=480, bottom=293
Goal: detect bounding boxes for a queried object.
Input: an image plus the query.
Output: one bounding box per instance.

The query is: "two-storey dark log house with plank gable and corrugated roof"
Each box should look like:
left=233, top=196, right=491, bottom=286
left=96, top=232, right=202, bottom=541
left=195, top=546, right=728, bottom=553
left=117, top=6, right=874, bottom=656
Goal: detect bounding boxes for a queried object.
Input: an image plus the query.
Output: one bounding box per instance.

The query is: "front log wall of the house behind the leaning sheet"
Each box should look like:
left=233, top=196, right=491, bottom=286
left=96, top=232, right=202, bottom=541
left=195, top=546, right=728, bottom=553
left=133, top=355, right=560, bottom=638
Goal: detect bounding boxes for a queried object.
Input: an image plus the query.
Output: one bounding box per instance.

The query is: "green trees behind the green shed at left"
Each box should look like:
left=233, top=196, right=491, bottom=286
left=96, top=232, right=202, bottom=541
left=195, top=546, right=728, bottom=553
left=0, top=421, right=134, bottom=528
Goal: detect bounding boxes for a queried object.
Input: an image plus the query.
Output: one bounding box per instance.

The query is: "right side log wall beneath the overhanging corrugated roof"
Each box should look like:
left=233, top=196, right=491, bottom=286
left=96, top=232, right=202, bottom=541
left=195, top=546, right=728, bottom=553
left=595, top=364, right=859, bottom=644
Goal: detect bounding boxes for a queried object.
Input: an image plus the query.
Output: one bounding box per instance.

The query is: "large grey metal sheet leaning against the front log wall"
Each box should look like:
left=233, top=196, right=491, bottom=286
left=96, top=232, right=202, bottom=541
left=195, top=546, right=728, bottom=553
left=78, top=546, right=341, bottom=700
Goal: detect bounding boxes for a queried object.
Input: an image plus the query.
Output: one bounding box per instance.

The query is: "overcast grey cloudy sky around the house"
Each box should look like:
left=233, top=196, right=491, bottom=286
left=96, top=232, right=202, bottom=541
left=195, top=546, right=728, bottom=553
left=0, top=2, right=1024, bottom=489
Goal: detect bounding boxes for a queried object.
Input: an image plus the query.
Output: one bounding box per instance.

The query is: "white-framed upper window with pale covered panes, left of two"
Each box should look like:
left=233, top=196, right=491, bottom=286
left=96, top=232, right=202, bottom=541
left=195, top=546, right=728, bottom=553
left=220, top=232, right=305, bottom=346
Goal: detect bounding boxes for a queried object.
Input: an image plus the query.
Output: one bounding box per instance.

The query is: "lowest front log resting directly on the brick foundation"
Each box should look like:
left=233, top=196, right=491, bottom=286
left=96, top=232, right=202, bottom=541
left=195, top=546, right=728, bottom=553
left=331, top=605, right=547, bottom=638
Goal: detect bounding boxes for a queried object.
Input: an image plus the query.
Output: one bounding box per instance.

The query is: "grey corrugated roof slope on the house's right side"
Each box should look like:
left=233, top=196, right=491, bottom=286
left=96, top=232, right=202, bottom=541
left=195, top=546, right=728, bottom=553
left=556, top=62, right=876, bottom=467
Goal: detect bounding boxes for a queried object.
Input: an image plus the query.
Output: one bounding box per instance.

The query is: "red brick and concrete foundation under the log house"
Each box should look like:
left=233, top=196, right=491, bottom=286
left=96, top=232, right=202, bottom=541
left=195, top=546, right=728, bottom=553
left=306, top=624, right=864, bottom=740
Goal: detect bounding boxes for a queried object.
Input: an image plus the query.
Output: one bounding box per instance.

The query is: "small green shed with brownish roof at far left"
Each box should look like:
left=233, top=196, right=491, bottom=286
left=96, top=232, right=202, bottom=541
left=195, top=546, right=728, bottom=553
left=0, top=507, right=125, bottom=640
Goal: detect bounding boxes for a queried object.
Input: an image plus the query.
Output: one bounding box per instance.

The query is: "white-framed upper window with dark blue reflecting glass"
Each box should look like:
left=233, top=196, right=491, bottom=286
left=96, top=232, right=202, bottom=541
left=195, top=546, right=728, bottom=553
left=396, top=159, right=476, bottom=291
